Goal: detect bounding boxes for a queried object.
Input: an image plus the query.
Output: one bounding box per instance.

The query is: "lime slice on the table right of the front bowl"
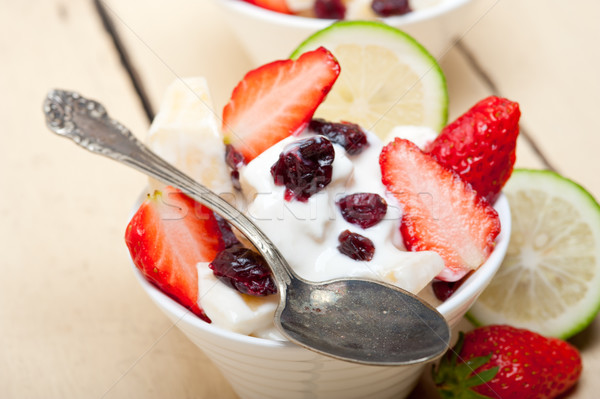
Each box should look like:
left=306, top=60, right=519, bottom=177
left=468, top=170, right=600, bottom=339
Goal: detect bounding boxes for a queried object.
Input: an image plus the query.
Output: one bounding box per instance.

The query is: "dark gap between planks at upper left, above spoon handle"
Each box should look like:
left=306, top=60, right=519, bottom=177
left=94, top=0, right=155, bottom=123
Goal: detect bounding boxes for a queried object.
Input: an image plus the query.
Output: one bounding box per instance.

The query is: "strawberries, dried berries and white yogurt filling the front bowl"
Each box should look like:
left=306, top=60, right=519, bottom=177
left=126, top=47, right=519, bottom=339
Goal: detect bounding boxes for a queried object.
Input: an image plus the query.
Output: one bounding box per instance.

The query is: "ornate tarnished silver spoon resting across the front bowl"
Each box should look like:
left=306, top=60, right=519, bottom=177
left=44, top=90, right=450, bottom=365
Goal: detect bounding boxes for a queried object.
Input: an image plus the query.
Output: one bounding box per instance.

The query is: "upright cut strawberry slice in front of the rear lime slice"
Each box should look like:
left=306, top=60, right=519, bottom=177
left=223, top=47, right=340, bottom=163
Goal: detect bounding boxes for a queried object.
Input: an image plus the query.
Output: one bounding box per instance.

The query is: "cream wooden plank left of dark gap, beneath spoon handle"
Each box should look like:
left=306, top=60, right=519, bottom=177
left=0, top=0, right=232, bottom=399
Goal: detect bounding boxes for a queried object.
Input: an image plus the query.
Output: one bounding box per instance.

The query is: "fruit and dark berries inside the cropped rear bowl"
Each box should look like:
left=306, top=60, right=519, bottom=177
left=242, top=0, right=443, bottom=20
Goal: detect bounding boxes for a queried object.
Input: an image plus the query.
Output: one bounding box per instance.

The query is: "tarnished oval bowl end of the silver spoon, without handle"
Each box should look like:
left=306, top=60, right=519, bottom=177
left=275, top=279, right=450, bottom=365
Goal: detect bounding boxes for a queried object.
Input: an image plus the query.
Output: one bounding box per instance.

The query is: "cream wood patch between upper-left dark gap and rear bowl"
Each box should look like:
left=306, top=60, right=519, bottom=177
left=95, top=0, right=251, bottom=122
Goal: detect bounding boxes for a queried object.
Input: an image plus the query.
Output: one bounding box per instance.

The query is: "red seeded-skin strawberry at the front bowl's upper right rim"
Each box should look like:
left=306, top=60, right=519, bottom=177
left=429, top=96, right=521, bottom=204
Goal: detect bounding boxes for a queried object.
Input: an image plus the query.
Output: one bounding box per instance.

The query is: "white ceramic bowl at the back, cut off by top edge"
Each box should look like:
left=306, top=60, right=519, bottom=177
left=213, top=0, right=477, bottom=66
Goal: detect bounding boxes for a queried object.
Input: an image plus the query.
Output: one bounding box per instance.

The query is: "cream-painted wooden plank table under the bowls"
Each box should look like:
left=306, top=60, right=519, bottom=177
left=0, top=0, right=600, bottom=398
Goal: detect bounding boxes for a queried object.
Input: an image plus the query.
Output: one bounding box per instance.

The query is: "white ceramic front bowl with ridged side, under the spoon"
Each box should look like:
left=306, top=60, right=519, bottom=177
left=133, top=196, right=511, bottom=399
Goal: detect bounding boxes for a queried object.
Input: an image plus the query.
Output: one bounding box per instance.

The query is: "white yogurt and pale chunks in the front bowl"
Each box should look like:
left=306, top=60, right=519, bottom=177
left=147, top=78, right=444, bottom=339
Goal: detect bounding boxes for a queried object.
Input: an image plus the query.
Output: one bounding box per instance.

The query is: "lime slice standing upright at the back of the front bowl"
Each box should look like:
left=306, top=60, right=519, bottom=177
left=291, top=21, right=448, bottom=139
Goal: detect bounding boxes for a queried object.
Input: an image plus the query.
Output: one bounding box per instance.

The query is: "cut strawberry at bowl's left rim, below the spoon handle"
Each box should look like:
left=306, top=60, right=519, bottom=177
left=125, top=187, right=225, bottom=322
